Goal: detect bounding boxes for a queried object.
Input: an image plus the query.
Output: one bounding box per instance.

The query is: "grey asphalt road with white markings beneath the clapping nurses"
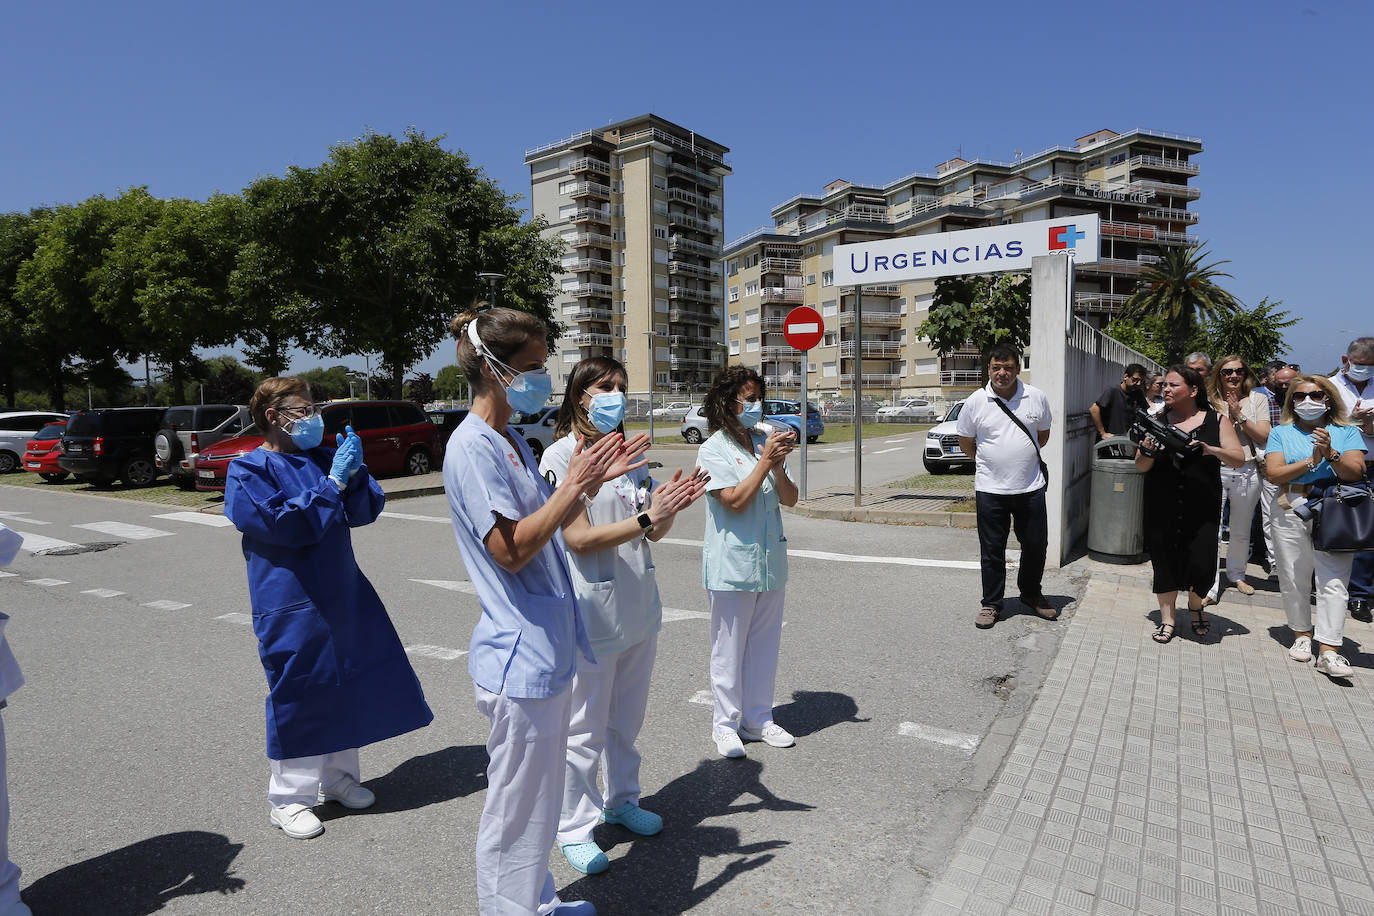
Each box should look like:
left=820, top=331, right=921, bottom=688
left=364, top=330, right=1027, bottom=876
left=0, top=441, right=1073, bottom=916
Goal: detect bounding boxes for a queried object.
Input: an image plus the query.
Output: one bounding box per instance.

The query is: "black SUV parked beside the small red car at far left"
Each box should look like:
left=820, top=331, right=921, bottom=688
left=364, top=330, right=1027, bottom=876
left=58, top=407, right=166, bottom=486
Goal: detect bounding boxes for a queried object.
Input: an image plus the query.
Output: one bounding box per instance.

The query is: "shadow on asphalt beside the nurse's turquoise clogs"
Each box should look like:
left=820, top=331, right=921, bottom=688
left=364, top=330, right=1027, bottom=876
left=558, top=751, right=813, bottom=916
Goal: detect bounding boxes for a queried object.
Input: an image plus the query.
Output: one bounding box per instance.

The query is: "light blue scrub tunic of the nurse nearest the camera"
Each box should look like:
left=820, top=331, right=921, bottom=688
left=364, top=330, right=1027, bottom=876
left=444, top=413, right=595, bottom=699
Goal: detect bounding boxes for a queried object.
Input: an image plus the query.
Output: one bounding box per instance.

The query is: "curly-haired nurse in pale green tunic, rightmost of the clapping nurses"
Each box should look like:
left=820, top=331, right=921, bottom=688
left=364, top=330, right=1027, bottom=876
left=697, top=365, right=797, bottom=757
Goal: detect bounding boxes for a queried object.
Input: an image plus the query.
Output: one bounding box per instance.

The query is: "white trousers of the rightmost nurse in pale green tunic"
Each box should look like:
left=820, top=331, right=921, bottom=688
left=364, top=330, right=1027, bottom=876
left=706, top=588, right=786, bottom=729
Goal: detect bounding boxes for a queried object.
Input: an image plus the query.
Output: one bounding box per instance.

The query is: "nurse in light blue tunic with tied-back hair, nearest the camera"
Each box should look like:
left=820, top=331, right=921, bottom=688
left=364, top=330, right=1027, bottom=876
left=444, top=305, right=647, bottom=916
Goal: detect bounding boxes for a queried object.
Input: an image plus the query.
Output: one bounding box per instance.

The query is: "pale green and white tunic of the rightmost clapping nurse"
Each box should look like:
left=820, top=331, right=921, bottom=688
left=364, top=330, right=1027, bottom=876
left=697, top=430, right=790, bottom=592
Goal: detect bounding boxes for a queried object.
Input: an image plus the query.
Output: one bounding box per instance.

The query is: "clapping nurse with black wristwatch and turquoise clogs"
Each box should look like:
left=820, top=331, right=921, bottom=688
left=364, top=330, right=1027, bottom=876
left=539, top=356, right=709, bottom=875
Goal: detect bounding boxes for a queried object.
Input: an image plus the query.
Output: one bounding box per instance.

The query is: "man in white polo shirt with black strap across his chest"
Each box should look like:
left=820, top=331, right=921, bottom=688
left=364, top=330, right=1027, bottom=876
left=958, top=346, right=1059, bottom=630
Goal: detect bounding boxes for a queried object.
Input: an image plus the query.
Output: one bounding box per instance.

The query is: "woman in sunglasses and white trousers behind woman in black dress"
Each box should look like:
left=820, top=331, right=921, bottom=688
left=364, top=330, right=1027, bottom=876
left=1206, top=354, right=1270, bottom=604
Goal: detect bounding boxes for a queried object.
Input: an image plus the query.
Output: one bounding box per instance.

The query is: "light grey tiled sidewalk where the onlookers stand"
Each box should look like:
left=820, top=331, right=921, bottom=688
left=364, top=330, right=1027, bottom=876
left=922, top=562, right=1374, bottom=916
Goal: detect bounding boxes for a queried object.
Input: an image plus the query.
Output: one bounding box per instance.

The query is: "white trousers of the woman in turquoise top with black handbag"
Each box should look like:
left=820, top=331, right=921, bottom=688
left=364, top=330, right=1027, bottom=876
left=1272, top=507, right=1355, bottom=648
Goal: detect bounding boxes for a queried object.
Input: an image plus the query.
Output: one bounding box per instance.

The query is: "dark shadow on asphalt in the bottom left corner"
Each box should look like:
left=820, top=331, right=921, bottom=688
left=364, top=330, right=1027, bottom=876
left=22, top=831, right=245, bottom=916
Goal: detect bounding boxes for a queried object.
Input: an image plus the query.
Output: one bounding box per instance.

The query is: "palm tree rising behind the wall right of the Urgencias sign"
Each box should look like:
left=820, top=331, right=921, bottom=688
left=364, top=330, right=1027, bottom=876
left=1125, top=244, right=1241, bottom=364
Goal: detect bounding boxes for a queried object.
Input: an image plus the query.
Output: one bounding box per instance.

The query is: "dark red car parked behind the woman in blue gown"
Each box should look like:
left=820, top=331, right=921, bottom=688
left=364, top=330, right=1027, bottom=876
left=195, top=401, right=441, bottom=490
